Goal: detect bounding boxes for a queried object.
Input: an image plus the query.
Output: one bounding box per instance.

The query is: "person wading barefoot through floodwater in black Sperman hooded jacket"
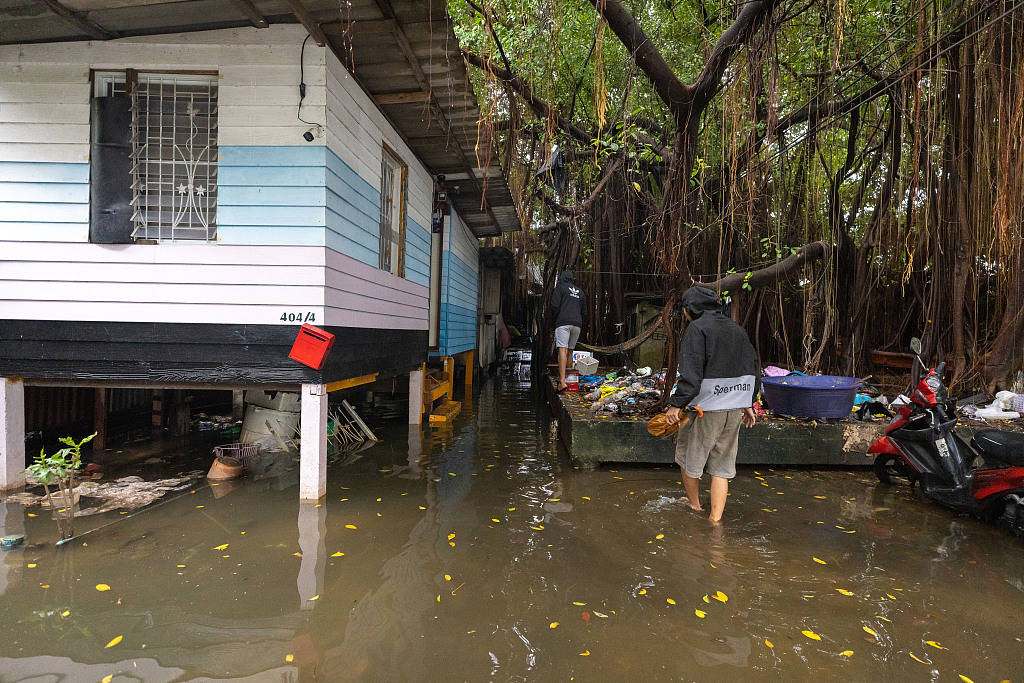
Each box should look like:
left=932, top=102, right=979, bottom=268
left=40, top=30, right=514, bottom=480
left=666, top=287, right=761, bottom=522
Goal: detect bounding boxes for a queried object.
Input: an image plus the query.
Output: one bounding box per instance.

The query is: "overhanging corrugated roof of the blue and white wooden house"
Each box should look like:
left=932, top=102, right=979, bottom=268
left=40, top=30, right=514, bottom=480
left=0, top=0, right=522, bottom=237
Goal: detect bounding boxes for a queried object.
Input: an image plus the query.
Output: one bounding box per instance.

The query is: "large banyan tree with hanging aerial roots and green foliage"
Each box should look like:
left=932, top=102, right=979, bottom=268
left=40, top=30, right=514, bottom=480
left=449, top=0, right=1024, bottom=392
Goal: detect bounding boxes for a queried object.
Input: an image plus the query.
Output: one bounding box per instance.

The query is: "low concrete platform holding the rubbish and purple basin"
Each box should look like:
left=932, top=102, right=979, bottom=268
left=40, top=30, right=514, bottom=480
left=546, top=381, right=885, bottom=467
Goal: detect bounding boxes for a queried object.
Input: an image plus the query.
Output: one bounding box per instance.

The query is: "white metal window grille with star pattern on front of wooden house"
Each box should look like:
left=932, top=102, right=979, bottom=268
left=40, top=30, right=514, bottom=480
left=128, top=72, right=217, bottom=241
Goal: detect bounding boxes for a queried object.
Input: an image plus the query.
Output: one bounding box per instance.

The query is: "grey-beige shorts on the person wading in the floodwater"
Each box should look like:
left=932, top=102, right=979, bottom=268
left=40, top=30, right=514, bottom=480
left=676, top=410, right=743, bottom=479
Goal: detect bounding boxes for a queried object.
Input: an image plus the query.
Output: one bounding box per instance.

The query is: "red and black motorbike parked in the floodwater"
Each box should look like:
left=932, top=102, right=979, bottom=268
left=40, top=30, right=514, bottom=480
left=868, top=338, right=1024, bottom=530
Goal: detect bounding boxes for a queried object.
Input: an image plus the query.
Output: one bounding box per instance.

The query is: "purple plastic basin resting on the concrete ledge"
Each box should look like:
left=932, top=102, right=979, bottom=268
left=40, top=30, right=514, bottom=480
left=761, top=375, right=863, bottom=418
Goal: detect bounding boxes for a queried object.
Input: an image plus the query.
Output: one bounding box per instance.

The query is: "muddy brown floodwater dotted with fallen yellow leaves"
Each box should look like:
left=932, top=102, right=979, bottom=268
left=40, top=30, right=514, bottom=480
left=0, top=381, right=1024, bottom=683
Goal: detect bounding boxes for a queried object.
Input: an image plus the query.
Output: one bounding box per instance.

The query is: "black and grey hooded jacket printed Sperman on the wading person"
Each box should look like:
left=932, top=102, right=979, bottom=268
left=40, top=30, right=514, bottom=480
left=669, top=287, right=761, bottom=412
